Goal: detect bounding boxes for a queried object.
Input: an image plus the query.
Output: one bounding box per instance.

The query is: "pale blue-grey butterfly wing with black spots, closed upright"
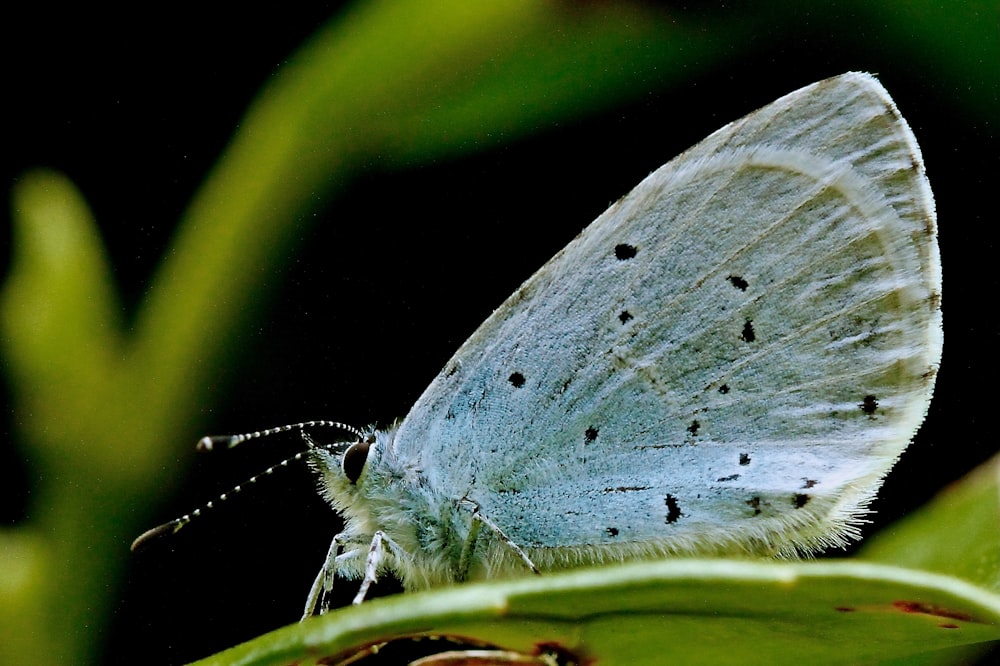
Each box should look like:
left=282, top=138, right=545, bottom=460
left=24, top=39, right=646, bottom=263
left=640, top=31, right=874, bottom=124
left=393, top=73, right=942, bottom=565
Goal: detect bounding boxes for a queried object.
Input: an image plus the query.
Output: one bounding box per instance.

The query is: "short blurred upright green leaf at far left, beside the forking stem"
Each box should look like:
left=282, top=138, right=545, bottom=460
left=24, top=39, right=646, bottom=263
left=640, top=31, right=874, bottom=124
left=0, top=172, right=121, bottom=459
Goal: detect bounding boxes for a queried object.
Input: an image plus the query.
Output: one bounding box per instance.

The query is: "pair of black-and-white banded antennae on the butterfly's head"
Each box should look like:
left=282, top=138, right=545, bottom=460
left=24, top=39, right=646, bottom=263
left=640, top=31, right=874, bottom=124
left=131, top=421, right=365, bottom=552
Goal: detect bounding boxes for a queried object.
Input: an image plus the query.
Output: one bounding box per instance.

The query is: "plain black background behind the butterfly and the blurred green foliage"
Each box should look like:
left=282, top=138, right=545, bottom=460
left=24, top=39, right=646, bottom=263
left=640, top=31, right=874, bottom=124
left=0, top=3, right=1000, bottom=663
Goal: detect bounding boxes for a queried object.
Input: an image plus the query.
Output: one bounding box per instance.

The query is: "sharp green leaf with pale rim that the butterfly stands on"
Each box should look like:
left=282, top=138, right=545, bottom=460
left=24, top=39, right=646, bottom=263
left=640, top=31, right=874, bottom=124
left=191, top=560, right=1000, bottom=666
